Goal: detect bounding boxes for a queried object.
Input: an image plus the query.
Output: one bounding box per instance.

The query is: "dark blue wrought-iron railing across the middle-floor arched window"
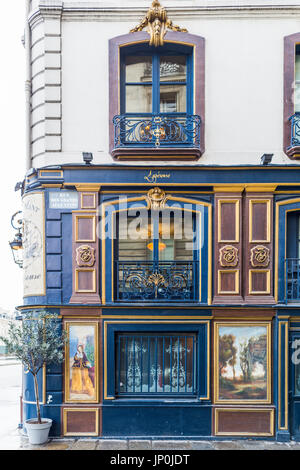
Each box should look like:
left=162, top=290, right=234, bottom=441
left=116, top=261, right=197, bottom=302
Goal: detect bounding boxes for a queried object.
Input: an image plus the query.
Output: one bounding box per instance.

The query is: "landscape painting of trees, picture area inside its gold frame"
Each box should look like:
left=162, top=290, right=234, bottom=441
left=218, top=325, right=269, bottom=401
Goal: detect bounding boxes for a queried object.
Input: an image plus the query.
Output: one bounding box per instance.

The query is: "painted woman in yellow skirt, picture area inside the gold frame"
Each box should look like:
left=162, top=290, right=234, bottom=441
left=68, top=325, right=96, bottom=401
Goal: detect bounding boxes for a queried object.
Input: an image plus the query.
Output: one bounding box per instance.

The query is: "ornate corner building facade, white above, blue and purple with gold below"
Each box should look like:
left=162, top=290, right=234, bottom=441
left=19, top=0, right=300, bottom=440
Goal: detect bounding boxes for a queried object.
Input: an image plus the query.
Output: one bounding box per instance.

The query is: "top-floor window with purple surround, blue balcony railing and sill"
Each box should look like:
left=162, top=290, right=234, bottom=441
left=110, top=32, right=204, bottom=160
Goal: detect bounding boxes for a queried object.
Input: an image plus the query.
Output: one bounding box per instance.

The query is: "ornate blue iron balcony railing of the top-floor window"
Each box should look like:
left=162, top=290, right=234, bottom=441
left=113, top=113, right=201, bottom=148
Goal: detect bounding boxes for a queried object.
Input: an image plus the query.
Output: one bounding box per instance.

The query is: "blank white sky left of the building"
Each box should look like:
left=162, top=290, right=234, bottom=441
left=0, top=0, right=26, bottom=311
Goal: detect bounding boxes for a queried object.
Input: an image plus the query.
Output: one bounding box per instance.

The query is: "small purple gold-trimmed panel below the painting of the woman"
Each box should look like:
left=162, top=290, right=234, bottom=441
left=63, top=408, right=100, bottom=436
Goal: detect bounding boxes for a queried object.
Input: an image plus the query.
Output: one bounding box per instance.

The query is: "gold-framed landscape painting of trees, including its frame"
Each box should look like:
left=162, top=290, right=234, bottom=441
left=214, top=322, right=272, bottom=404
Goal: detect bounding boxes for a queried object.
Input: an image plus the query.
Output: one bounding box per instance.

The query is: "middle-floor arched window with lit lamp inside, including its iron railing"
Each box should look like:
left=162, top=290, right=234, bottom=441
left=115, top=209, right=199, bottom=302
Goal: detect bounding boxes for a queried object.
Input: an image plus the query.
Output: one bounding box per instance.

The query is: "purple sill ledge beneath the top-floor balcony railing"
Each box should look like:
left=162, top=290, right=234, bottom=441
left=111, top=147, right=202, bottom=161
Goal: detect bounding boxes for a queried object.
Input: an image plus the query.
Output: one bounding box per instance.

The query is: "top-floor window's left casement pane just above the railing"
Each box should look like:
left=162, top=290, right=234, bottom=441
left=126, top=85, right=152, bottom=113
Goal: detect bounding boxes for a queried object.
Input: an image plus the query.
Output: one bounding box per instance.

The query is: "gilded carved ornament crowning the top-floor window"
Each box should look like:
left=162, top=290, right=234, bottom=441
left=130, top=0, right=187, bottom=47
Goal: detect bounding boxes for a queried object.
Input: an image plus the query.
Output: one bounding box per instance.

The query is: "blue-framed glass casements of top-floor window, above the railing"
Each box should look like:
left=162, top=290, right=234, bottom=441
left=121, top=45, right=193, bottom=114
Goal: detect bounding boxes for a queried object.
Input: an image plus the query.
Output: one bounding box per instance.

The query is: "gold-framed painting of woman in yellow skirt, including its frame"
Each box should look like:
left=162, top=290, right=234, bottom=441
left=64, top=320, right=99, bottom=403
